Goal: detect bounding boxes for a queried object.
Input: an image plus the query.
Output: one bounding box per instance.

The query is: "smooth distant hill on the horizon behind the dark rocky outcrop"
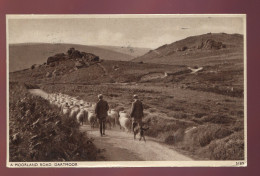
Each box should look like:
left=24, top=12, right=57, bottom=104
left=9, top=43, right=147, bottom=72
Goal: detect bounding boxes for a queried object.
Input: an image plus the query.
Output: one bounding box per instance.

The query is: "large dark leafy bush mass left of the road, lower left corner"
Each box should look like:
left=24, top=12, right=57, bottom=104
left=9, top=84, right=98, bottom=162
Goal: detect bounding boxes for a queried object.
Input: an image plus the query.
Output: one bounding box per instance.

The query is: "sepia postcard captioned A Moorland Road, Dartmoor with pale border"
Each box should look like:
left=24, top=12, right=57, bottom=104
left=6, top=14, right=247, bottom=167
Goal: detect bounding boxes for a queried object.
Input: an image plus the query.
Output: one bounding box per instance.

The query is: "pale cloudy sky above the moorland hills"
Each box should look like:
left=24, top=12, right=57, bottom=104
left=8, top=15, right=244, bottom=49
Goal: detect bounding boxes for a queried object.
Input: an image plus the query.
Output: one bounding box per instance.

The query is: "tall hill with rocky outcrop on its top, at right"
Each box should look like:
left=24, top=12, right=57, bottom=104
left=133, top=33, right=243, bottom=66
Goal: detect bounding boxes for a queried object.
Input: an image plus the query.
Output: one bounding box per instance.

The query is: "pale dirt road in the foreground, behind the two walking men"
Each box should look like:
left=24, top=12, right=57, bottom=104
left=81, top=125, right=192, bottom=161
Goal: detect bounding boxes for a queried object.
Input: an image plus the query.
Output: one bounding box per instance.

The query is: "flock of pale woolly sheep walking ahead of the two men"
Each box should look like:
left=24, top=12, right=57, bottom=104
left=46, top=93, right=132, bottom=132
